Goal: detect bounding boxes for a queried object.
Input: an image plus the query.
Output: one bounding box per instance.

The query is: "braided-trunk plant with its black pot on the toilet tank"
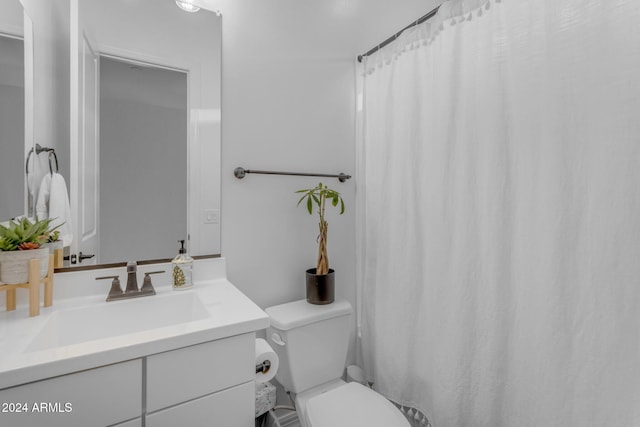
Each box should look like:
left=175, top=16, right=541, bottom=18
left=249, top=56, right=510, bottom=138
left=296, top=183, right=344, bottom=304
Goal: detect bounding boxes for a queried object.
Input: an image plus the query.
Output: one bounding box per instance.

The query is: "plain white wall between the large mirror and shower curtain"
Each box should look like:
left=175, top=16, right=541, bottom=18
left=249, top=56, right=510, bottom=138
left=208, top=0, right=442, bottom=307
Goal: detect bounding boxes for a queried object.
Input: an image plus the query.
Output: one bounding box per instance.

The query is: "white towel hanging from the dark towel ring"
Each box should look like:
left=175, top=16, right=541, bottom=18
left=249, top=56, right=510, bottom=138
left=36, top=172, right=73, bottom=246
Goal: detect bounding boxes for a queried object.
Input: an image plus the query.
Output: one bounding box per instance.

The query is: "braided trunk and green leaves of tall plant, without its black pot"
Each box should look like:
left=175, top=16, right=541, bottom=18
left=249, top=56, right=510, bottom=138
left=296, top=183, right=344, bottom=275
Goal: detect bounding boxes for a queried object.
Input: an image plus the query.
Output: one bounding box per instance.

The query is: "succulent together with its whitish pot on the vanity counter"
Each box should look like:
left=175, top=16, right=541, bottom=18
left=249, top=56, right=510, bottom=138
left=0, top=218, right=57, bottom=284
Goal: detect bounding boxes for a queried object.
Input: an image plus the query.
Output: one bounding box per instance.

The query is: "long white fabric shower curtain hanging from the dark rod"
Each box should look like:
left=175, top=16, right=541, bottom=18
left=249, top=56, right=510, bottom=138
left=358, top=0, right=640, bottom=427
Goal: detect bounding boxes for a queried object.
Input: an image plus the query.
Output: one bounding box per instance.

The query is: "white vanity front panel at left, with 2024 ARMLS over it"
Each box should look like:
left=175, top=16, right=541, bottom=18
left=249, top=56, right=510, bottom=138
left=0, top=359, right=142, bottom=427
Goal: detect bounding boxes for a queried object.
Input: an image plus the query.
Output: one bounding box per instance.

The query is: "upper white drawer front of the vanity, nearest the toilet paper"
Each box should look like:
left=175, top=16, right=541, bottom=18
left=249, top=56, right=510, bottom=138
left=147, top=333, right=255, bottom=412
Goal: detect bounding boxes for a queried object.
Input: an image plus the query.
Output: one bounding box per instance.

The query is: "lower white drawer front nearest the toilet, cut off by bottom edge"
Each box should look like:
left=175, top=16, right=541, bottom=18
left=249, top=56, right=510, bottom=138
left=145, top=382, right=255, bottom=427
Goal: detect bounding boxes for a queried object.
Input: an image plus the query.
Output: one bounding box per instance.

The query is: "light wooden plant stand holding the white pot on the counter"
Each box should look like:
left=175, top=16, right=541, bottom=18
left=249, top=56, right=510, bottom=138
left=0, top=249, right=62, bottom=317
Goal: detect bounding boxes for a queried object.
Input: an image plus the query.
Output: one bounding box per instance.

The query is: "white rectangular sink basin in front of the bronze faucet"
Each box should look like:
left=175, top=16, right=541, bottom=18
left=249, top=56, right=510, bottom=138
left=26, top=292, right=209, bottom=352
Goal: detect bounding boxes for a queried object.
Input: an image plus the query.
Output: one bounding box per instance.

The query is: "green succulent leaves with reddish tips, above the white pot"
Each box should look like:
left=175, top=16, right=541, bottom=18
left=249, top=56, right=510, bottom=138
left=0, top=218, right=60, bottom=251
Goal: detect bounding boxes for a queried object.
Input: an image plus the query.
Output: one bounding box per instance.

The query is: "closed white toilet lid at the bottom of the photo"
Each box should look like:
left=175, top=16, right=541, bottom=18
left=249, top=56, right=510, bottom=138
left=306, top=383, right=409, bottom=427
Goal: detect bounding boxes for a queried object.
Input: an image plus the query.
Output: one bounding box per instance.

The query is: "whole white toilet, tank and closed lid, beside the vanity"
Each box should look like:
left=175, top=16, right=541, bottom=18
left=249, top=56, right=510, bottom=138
left=265, top=300, right=409, bottom=427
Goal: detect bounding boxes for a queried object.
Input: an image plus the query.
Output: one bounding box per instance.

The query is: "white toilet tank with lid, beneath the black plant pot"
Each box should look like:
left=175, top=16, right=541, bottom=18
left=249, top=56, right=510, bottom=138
left=265, top=300, right=352, bottom=393
